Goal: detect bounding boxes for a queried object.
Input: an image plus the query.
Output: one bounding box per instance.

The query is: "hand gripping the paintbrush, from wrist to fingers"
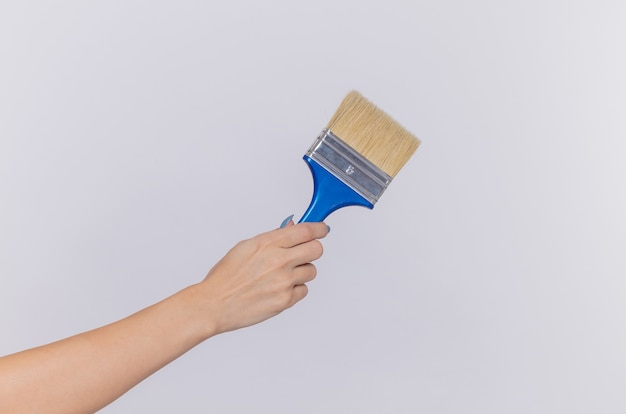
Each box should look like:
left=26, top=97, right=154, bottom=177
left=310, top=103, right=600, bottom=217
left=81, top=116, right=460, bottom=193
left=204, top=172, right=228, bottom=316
left=198, top=223, right=328, bottom=333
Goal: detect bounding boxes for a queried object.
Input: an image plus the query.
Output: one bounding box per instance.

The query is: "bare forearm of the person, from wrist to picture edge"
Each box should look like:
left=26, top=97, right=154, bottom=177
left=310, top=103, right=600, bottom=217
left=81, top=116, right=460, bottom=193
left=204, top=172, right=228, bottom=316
left=0, top=285, right=215, bottom=413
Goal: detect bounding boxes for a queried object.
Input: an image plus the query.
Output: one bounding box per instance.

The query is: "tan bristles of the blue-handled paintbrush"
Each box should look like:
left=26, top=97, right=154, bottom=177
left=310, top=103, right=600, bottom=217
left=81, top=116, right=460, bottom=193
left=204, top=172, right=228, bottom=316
left=327, top=91, right=420, bottom=177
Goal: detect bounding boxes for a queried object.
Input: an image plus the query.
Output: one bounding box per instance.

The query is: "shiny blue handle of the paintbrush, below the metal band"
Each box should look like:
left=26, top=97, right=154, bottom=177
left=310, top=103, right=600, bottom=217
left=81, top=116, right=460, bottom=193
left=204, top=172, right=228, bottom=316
left=299, top=155, right=374, bottom=223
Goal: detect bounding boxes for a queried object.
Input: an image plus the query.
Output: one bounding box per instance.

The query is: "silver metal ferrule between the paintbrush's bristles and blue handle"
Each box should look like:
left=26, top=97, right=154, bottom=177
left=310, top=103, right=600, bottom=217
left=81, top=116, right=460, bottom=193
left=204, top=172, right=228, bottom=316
left=306, top=128, right=391, bottom=204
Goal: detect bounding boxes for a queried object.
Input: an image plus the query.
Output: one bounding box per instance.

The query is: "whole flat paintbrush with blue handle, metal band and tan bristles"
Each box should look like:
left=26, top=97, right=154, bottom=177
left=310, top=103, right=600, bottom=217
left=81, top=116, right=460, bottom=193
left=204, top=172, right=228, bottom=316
left=300, top=91, right=420, bottom=222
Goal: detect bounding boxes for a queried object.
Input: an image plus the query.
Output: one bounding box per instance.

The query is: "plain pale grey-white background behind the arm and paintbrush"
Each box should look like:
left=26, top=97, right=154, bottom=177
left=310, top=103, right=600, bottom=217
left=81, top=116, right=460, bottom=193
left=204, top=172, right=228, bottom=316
left=0, top=0, right=626, bottom=414
